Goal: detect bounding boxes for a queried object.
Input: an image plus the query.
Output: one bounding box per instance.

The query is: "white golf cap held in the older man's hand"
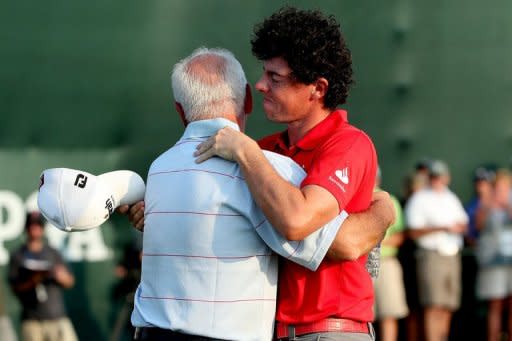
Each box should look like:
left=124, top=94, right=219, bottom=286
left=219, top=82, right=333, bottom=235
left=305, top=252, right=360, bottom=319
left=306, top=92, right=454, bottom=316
left=37, top=168, right=146, bottom=232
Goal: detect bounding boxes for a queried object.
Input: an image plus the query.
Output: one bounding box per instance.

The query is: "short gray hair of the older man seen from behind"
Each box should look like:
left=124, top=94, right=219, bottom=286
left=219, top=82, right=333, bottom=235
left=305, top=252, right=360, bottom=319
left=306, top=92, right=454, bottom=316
left=171, top=47, right=247, bottom=122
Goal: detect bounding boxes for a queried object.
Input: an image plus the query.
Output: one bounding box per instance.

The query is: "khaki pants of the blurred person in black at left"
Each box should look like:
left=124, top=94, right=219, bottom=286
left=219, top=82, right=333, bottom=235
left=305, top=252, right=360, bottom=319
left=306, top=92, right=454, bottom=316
left=21, top=317, right=78, bottom=341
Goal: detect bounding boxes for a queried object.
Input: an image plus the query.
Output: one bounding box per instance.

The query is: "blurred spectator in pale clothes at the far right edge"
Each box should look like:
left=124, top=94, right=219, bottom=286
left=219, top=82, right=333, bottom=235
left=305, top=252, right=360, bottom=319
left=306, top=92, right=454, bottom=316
left=476, top=169, right=512, bottom=341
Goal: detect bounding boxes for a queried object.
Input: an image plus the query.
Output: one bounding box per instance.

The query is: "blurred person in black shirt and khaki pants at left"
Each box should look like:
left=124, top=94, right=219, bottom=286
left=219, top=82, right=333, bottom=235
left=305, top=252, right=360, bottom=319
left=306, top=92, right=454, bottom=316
left=8, top=212, right=77, bottom=341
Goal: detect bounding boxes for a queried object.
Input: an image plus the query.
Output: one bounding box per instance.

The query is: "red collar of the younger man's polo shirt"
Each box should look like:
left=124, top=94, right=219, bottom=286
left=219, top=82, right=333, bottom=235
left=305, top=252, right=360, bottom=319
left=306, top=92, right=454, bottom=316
left=276, top=109, right=348, bottom=150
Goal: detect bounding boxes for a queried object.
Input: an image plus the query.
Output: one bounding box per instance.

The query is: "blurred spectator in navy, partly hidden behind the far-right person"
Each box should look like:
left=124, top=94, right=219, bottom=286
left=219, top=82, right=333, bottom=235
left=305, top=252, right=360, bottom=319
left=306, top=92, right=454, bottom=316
left=466, top=167, right=495, bottom=246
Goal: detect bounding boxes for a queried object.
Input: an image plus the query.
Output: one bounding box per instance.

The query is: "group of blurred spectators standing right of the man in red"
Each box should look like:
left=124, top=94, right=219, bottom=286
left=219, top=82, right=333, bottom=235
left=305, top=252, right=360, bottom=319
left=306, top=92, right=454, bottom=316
left=375, top=160, right=512, bottom=341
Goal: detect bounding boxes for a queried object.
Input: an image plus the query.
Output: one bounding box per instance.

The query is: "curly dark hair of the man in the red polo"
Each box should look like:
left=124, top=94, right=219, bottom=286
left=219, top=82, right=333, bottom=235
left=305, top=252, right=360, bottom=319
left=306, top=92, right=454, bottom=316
left=251, top=6, right=354, bottom=109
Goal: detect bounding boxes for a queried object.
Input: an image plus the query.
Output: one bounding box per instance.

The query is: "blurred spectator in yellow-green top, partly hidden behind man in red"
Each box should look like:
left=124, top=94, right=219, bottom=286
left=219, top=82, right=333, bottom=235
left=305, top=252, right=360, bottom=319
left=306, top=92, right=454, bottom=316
left=374, top=167, right=408, bottom=341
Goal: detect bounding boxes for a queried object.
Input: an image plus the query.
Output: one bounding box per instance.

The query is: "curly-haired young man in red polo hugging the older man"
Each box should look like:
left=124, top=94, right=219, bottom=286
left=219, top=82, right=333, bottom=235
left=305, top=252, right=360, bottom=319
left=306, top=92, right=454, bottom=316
left=196, top=8, right=377, bottom=340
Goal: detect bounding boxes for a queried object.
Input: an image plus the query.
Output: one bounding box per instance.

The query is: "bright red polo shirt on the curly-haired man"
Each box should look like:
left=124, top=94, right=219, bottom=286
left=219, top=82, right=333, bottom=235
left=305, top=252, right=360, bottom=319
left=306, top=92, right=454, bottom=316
left=259, top=110, right=377, bottom=324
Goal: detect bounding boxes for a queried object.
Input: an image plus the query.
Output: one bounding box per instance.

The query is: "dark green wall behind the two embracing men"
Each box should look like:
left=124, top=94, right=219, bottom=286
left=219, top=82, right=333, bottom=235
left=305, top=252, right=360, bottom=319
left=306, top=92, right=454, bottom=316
left=0, top=0, right=512, bottom=340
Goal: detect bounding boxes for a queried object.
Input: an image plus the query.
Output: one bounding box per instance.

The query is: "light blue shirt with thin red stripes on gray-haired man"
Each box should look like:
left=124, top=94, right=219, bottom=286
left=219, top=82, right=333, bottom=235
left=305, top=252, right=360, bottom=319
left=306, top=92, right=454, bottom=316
left=132, top=119, right=346, bottom=340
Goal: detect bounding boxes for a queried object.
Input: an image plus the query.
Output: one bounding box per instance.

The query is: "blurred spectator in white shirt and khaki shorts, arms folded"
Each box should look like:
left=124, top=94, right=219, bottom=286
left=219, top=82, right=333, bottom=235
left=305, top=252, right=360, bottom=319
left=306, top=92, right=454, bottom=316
left=405, top=160, right=468, bottom=341
